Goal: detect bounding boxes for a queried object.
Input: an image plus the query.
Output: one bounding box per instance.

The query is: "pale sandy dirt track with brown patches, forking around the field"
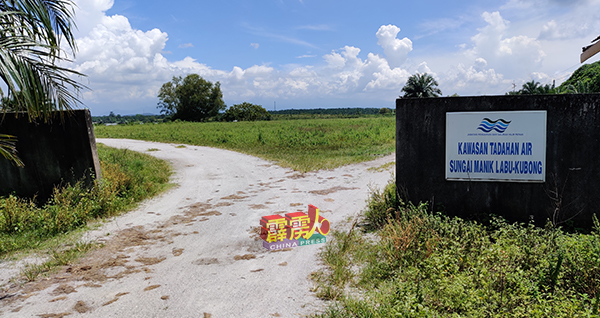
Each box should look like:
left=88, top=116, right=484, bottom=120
left=0, top=139, right=394, bottom=317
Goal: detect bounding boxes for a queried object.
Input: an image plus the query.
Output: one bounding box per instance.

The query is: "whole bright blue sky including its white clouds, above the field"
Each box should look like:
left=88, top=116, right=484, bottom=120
left=70, top=0, right=600, bottom=115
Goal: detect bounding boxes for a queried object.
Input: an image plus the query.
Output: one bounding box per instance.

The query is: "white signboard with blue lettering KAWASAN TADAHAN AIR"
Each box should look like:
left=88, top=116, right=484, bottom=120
left=445, top=111, right=546, bottom=182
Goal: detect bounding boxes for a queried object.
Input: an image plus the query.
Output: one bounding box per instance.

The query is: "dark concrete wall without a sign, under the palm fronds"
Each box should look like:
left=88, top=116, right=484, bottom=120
left=0, top=109, right=100, bottom=202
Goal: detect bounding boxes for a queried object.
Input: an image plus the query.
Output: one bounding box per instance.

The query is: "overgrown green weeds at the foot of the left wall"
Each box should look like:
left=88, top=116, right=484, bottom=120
left=0, top=144, right=171, bottom=256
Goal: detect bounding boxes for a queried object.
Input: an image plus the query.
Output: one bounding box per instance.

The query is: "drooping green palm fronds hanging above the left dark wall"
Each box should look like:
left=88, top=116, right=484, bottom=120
left=0, top=0, right=86, bottom=163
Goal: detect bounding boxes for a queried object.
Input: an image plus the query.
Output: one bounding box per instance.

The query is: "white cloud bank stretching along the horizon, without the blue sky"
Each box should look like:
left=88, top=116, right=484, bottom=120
left=74, top=0, right=600, bottom=114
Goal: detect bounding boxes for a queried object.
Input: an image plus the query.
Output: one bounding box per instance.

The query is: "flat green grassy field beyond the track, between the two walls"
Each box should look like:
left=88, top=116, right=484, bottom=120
left=95, top=116, right=396, bottom=171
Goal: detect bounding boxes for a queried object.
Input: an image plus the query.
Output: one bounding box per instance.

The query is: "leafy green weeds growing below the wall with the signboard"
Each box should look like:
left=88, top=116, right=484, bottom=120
left=313, top=184, right=600, bottom=317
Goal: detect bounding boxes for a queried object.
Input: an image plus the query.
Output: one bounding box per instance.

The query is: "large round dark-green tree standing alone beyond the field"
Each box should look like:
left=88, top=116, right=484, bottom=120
left=157, top=74, right=226, bottom=121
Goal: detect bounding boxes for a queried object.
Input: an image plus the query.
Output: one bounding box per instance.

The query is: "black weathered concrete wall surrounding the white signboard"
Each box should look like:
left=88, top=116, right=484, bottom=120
left=396, top=94, right=600, bottom=228
